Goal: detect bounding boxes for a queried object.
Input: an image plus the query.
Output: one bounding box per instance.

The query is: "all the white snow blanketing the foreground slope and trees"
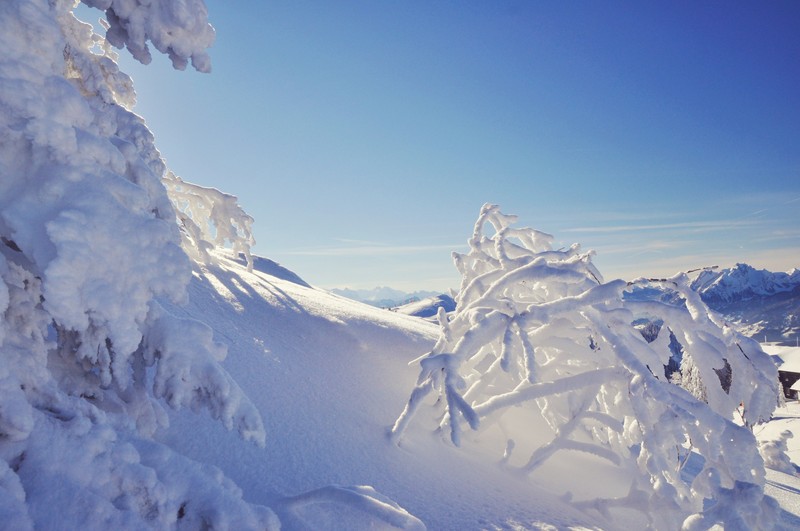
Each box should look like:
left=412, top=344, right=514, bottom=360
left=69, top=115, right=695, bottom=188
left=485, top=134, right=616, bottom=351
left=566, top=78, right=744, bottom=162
left=0, top=0, right=800, bottom=530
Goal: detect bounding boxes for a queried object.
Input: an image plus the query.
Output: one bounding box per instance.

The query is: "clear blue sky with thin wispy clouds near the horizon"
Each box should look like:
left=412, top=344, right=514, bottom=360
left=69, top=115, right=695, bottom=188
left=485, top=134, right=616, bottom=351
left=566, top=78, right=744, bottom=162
left=86, top=0, right=800, bottom=290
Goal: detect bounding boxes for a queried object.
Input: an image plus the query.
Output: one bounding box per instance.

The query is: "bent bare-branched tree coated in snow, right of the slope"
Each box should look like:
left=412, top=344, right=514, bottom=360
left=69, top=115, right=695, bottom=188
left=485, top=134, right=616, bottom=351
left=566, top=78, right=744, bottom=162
left=391, top=204, right=777, bottom=529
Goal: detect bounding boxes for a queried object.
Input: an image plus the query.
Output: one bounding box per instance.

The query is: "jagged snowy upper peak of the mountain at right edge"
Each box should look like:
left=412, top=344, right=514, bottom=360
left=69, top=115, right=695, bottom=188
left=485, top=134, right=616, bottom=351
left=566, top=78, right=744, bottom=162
left=692, top=264, right=800, bottom=302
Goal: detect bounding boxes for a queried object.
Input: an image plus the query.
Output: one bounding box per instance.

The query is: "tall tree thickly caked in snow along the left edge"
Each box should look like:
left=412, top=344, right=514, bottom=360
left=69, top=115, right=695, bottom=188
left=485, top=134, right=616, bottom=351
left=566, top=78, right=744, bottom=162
left=0, top=0, right=275, bottom=529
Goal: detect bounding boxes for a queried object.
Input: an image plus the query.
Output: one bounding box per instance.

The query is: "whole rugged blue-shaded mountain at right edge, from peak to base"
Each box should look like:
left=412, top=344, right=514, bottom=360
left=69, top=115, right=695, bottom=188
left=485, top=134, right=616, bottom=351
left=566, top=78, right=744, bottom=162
left=692, top=264, right=800, bottom=344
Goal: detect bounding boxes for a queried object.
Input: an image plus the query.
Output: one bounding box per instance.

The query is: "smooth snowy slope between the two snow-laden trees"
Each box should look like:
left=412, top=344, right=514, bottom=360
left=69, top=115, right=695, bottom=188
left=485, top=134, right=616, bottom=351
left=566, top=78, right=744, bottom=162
left=153, top=252, right=596, bottom=529
